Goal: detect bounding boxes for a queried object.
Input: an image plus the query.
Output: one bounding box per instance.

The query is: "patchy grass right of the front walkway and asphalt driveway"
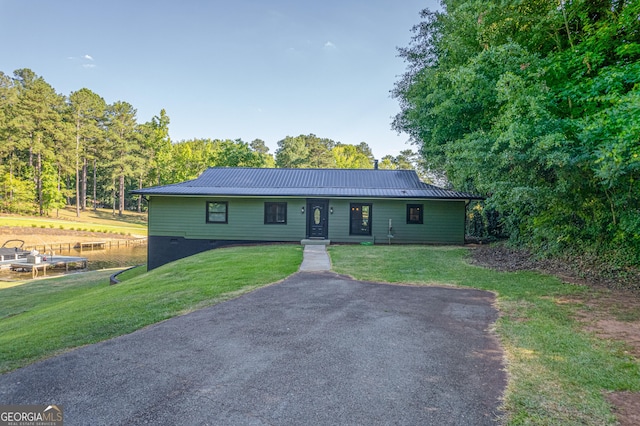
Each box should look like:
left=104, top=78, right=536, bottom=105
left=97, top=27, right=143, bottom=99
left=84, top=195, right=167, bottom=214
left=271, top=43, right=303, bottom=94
left=329, top=246, right=640, bottom=425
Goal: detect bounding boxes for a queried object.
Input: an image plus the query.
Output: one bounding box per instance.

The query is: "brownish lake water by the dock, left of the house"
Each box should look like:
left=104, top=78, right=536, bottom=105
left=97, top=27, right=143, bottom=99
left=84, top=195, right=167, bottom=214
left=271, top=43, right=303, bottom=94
left=0, top=244, right=147, bottom=281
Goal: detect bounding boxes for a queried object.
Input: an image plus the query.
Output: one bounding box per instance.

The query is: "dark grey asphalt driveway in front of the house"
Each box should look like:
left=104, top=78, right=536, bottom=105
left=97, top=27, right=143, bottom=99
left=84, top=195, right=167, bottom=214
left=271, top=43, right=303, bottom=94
left=0, top=272, right=506, bottom=425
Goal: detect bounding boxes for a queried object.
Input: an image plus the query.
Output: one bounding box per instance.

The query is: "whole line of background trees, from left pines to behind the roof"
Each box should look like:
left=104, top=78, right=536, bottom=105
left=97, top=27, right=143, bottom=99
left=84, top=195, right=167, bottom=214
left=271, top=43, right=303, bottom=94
left=0, top=69, right=432, bottom=215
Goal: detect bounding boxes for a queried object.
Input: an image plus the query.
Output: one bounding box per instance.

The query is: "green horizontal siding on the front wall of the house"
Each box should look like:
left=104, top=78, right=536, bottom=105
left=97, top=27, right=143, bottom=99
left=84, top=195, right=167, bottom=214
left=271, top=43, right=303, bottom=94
left=149, top=196, right=465, bottom=244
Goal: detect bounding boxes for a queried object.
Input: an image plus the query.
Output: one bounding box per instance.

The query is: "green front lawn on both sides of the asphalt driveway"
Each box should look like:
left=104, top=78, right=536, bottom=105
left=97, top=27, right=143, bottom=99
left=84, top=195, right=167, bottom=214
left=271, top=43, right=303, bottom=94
left=0, top=241, right=640, bottom=425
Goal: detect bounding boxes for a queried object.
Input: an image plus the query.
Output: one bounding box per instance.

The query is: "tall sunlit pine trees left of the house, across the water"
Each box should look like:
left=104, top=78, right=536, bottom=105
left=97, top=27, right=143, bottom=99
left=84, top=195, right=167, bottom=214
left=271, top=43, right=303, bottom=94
left=0, top=69, right=182, bottom=215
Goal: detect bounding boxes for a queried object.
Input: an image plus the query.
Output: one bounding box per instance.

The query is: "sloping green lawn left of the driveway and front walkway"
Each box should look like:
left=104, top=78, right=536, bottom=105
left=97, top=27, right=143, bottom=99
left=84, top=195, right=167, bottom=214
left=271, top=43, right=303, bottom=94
left=0, top=245, right=302, bottom=373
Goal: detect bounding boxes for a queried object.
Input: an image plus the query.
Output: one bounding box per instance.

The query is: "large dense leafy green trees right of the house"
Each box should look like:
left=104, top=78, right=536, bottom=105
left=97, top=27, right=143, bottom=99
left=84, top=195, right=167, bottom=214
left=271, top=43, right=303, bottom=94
left=393, top=0, right=640, bottom=264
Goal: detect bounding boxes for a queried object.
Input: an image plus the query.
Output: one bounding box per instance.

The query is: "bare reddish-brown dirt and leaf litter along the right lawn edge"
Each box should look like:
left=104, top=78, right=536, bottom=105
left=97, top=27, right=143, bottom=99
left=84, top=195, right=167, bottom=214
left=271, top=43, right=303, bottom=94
left=471, top=246, right=640, bottom=426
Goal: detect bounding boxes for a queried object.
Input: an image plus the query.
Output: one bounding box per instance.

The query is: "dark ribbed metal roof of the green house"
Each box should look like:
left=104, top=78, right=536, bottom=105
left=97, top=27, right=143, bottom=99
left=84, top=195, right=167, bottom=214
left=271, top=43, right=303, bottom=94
left=132, top=167, right=479, bottom=200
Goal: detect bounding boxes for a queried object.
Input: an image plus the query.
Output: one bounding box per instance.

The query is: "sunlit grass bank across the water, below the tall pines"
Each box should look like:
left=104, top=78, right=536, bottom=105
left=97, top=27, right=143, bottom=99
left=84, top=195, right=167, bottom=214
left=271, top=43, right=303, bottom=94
left=0, top=208, right=147, bottom=235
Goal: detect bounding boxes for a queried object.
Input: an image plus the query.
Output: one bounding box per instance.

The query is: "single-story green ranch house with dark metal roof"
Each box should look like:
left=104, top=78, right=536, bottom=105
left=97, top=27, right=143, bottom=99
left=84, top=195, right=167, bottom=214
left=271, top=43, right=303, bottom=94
left=133, top=167, right=478, bottom=269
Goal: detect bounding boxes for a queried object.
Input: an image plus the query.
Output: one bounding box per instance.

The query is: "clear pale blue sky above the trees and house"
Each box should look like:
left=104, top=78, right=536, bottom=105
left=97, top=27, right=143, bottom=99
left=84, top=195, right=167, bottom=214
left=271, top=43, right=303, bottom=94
left=0, top=0, right=439, bottom=158
